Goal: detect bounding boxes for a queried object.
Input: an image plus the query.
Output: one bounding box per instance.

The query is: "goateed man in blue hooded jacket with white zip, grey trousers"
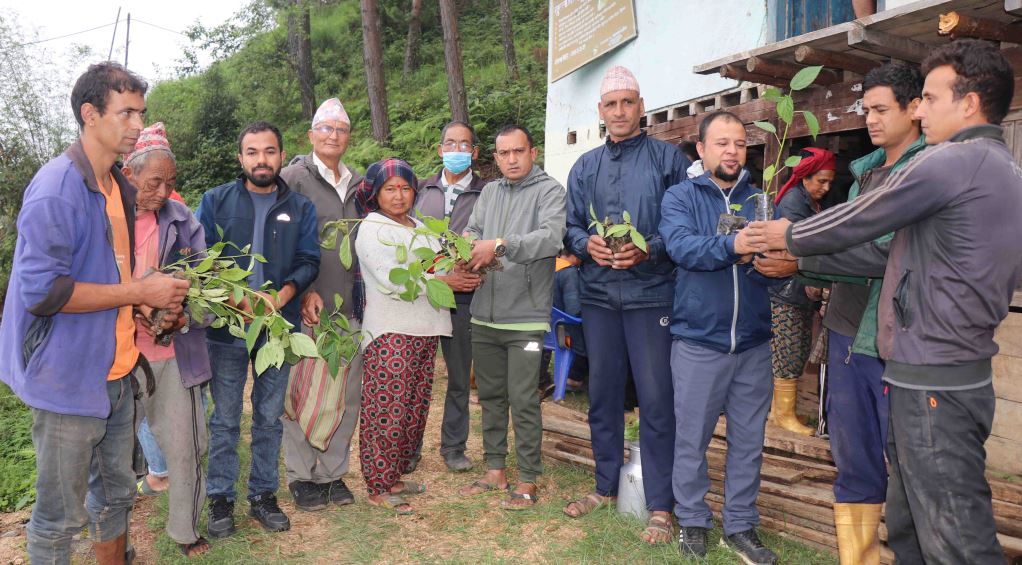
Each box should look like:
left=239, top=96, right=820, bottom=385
left=658, top=111, right=777, bottom=564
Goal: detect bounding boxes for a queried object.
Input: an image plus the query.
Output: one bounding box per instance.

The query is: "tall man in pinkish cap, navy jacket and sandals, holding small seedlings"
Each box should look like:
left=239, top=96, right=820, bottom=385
left=564, top=66, right=691, bottom=544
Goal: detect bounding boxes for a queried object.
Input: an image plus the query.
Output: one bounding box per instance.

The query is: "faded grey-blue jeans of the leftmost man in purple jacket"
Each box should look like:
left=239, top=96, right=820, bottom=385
left=26, top=376, right=135, bottom=563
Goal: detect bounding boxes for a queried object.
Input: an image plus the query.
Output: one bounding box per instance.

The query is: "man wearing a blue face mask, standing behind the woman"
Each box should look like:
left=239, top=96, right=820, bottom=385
left=415, top=122, right=486, bottom=471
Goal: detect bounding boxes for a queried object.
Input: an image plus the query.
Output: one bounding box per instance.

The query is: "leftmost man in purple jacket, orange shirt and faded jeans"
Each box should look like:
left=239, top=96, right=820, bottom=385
left=0, top=62, right=188, bottom=564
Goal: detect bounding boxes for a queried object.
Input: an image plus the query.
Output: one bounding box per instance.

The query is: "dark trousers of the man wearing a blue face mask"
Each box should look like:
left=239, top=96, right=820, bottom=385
left=440, top=304, right=472, bottom=455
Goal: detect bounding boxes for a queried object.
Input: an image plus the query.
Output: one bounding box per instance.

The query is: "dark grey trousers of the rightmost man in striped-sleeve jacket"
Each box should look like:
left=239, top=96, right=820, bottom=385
left=886, top=384, right=1005, bottom=565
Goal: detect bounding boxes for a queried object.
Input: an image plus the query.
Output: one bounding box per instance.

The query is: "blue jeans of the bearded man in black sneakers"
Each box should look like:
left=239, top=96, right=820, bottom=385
left=205, top=341, right=290, bottom=501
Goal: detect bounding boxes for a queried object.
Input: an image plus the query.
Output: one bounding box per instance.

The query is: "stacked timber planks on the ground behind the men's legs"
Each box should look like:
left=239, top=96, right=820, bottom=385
left=543, top=403, right=1022, bottom=565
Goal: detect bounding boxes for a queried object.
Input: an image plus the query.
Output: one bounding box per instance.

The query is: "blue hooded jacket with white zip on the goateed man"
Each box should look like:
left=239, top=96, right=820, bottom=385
left=660, top=170, right=786, bottom=354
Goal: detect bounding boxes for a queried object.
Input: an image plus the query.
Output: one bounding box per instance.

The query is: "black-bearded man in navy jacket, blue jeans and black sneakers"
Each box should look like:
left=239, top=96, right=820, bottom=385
left=196, top=122, right=320, bottom=537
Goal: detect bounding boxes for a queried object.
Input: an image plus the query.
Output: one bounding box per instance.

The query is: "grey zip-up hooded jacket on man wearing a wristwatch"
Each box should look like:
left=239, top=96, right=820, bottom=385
left=465, top=166, right=565, bottom=324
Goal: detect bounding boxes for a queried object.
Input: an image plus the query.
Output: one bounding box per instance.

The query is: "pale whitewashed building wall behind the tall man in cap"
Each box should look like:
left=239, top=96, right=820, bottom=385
left=544, top=0, right=768, bottom=183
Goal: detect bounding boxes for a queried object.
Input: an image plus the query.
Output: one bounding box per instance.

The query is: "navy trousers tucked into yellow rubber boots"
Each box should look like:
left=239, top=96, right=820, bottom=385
left=827, top=331, right=888, bottom=504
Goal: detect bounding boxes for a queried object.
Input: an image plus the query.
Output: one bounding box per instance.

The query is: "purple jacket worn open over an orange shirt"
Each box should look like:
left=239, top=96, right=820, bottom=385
left=0, top=141, right=136, bottom=418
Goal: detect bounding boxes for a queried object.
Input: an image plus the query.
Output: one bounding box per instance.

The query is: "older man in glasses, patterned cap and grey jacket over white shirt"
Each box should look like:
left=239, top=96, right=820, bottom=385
left=280, top=98, right=362, bottom=511
